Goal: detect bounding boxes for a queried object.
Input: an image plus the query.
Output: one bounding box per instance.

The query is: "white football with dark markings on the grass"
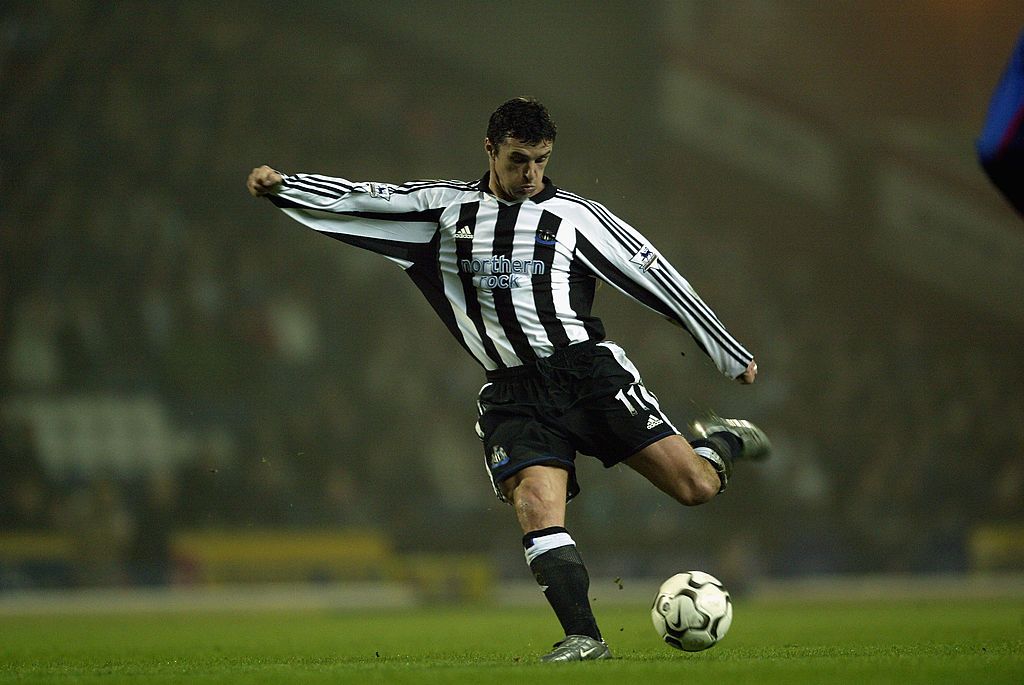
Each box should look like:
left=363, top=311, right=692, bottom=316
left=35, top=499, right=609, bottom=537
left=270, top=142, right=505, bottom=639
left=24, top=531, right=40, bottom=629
left=650, top=571, right=732, bottom=651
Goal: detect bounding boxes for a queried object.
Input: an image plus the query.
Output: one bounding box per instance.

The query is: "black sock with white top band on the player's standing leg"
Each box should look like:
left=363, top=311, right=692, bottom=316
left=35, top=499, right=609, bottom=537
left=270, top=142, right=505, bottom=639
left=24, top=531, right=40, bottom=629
left=522, top=526, right=601, bottom=640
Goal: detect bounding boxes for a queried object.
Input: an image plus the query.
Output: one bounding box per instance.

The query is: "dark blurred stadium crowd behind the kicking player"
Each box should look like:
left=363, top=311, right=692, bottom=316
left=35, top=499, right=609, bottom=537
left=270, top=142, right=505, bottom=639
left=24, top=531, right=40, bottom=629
left=0, top=0, right=1024, bottom=590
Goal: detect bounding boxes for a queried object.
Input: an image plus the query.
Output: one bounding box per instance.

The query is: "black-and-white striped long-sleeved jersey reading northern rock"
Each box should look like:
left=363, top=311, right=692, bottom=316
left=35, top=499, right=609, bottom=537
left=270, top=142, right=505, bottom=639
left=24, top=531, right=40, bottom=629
left=269, top=168, right=753, bottom=378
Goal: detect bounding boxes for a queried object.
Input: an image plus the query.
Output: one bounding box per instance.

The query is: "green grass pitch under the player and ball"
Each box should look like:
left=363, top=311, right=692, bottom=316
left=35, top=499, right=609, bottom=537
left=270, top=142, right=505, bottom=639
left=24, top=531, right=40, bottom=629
left=0, top=597, right=1024, bottom=685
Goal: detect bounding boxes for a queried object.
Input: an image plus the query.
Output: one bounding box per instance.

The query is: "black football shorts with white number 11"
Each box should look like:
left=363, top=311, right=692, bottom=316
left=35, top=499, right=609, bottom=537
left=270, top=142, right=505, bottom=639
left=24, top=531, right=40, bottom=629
left=476, top=340, right=679, bottom=502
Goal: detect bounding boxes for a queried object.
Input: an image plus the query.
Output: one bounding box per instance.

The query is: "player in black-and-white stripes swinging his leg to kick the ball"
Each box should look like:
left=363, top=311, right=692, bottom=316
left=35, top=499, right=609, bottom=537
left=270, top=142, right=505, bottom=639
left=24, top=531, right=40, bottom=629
left=248, top=98, right=769, bottom=661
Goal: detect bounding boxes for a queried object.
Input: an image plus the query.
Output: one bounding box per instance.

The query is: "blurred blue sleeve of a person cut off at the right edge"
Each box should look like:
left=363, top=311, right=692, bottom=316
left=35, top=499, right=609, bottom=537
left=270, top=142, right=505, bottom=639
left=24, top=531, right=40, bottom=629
left=978, top=28, right=1024, bottom=216
